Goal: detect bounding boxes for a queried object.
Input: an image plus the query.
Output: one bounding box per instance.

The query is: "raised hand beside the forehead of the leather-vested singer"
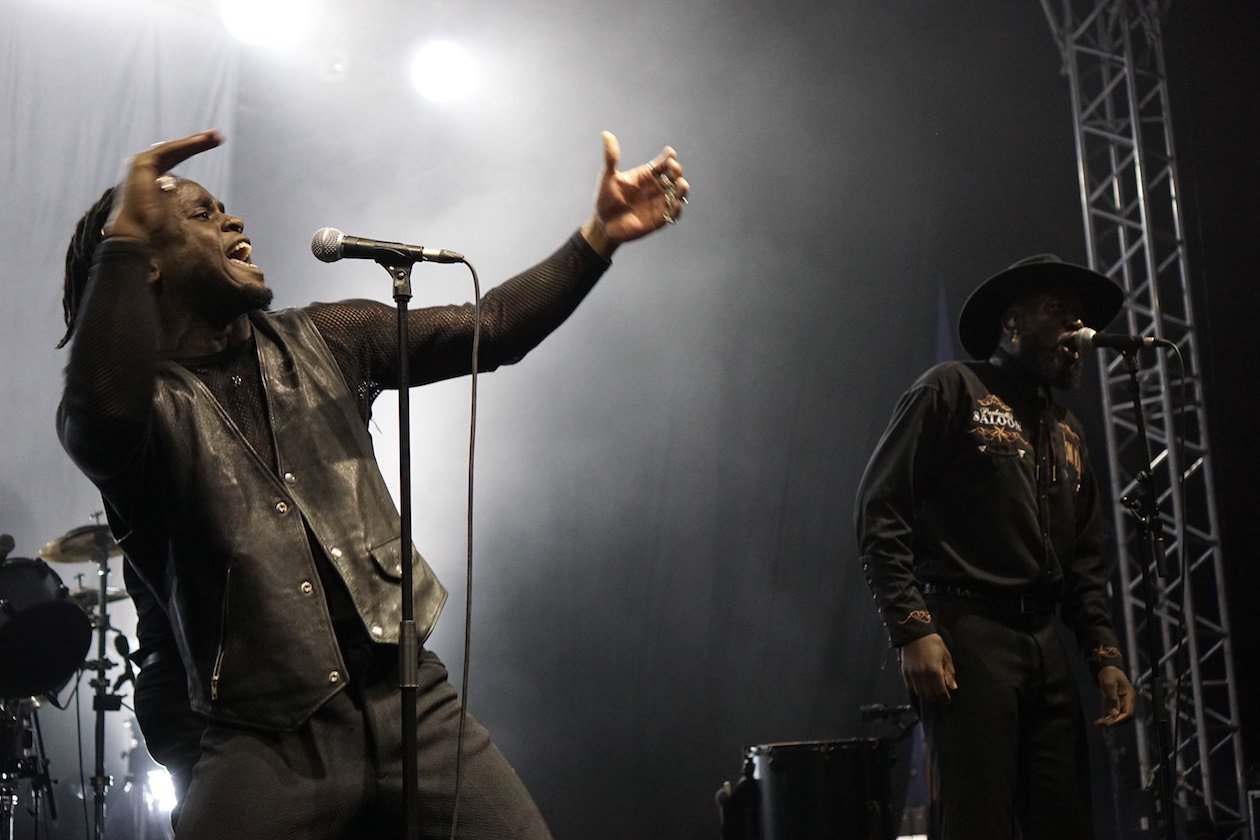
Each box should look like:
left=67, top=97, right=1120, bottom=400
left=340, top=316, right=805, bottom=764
left=105, top=130, right=223, bottom=241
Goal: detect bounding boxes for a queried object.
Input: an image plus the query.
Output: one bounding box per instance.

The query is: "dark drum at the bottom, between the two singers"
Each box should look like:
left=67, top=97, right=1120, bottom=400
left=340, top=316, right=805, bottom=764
left=718, top=738, right=895, bottom=840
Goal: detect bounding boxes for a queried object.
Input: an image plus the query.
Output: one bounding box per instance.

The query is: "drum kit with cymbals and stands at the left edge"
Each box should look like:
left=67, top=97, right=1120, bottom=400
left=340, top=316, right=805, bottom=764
left=0, top=524, right=143, bottom=840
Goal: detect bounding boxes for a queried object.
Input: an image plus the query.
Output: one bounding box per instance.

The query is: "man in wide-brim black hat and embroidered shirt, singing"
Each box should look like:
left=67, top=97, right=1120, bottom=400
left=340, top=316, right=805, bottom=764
left=857, top=254, right=1134, bottom=840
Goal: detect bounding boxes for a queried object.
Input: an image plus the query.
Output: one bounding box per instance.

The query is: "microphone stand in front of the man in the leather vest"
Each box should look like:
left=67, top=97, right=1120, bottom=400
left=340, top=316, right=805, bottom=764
left=377, top=256, right=420, bottom=840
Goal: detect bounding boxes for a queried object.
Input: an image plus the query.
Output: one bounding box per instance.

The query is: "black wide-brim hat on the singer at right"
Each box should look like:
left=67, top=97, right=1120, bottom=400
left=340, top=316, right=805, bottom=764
left=958, top=254, right=1124, bottom=359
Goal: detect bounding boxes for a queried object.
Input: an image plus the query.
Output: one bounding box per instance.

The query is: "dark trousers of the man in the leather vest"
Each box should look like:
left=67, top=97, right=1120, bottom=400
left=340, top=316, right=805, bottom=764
left=175, top=652, right=551, bottom=840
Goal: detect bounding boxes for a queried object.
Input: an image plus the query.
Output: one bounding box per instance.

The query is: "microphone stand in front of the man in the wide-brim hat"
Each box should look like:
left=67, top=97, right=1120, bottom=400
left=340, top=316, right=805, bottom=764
left=1120, top=349, right=1177, bottom=840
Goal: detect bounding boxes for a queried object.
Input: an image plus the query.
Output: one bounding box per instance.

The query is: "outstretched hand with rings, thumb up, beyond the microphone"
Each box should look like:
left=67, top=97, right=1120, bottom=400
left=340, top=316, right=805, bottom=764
left=582, top=131, right=690, bottom=253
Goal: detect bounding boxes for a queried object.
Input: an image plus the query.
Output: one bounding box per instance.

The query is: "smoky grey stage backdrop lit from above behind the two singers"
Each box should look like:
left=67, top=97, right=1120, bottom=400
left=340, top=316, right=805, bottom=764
left=0, top=0, right=1255, bottom=839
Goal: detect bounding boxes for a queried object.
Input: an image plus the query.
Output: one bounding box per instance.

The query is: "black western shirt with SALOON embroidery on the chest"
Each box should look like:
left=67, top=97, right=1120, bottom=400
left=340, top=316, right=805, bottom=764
left=857, top=350, right=1123, bottom=671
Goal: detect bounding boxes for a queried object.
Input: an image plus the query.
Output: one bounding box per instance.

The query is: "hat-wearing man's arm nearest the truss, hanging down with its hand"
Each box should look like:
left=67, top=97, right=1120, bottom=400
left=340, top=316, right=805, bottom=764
left=1063, top=450, right=1135, bottom=725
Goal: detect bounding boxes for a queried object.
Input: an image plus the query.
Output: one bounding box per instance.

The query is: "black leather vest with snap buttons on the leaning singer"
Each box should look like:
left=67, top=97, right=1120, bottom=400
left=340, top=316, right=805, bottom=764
left=110, top=310, right=446, bottom=729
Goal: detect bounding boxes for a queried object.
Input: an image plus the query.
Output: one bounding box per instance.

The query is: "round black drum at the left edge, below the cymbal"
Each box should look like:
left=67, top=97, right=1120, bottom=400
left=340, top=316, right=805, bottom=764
left=0, top=557, right=92, bottom=699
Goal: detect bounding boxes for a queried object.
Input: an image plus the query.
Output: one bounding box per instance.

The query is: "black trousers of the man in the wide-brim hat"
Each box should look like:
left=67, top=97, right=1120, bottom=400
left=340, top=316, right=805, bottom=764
left=920, top=598, right=1094, bottom=840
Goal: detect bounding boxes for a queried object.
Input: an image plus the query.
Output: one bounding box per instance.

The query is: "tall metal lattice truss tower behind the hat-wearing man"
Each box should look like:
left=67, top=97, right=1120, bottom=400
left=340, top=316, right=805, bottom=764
left=1041, top=0, right=1252, bottom=840
